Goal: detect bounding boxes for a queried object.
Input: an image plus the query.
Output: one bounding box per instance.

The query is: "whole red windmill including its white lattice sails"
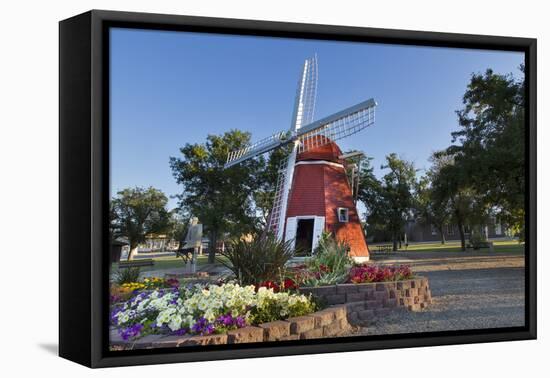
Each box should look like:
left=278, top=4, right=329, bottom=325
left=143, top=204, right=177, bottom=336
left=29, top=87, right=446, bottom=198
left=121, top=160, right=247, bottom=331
left=225, top=56, right=376, bottom=261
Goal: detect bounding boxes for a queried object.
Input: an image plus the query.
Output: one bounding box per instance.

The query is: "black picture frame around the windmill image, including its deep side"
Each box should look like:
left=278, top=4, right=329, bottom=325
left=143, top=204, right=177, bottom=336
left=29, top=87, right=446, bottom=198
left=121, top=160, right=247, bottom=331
left=59, top=10, right=537, bottom=368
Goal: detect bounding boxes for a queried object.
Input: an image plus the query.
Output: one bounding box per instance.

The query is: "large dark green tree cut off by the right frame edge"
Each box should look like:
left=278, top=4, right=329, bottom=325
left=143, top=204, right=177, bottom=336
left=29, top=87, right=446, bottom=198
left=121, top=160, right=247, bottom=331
left=448, top=67, right=525, bottom=239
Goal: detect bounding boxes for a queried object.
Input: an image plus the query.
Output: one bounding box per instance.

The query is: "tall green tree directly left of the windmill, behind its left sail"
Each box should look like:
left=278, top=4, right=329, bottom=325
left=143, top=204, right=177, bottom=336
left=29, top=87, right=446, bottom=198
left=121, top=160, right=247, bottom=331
left=170, top=130, right=265, bottom=263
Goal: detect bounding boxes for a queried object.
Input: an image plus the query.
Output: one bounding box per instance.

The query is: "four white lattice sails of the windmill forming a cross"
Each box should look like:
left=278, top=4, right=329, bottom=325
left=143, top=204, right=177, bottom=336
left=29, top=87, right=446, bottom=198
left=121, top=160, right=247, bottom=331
left=225, top=56, right=377, bottom=240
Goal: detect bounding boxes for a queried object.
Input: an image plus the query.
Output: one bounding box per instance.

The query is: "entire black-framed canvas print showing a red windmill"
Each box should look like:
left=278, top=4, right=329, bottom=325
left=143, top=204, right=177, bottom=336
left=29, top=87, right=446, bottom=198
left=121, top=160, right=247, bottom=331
left=59, top=11, right=536, bottom=367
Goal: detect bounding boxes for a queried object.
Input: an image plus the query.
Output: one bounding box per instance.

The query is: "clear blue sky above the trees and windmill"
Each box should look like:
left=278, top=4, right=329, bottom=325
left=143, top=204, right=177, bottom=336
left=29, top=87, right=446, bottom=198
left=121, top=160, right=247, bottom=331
left=110, top=29, right=524, bottom=208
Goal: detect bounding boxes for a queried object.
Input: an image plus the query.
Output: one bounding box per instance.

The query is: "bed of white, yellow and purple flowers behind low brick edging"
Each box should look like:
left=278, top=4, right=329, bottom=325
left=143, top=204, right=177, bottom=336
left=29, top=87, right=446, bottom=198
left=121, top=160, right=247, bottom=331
left=111, top=283, right=316, bottom=341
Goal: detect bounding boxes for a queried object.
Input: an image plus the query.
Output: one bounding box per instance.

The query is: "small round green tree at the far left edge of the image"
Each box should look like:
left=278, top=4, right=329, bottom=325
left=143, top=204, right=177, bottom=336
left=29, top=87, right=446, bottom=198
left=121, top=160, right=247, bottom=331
left=110, top=187, right=170, bottom=260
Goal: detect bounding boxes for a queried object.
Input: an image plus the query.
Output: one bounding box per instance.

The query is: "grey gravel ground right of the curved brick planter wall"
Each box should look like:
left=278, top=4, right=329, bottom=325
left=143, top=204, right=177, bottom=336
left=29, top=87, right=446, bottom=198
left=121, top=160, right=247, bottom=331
left=357, top=254, right=525, bottom=335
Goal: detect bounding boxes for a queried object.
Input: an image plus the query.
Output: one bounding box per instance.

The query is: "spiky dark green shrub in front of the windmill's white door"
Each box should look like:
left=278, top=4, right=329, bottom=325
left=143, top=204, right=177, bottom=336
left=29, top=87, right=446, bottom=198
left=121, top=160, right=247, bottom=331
left=219, top=233, right=293, bottom=285
